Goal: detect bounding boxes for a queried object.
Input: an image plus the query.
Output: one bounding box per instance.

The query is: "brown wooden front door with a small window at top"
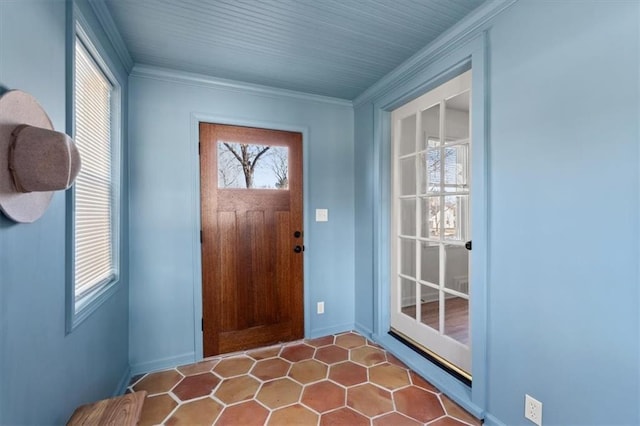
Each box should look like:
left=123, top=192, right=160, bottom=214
left=200, top=123, right=304, bottom=357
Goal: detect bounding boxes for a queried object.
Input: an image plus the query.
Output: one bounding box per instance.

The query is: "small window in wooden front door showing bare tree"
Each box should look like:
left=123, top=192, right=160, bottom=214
left=218, top=142, right=289, bottom=189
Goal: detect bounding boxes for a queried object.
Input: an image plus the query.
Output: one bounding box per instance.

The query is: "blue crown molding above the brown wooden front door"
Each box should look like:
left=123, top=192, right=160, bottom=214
left=129, top=64, right=353, bottom=108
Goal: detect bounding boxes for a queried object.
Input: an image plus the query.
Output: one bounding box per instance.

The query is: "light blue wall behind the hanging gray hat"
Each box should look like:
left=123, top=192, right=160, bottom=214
left=0, top=0, right=129, bottom=425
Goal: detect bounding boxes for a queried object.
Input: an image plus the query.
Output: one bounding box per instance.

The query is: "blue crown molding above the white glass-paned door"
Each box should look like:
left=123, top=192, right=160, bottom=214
left=353, top=0, right=518, bottom=107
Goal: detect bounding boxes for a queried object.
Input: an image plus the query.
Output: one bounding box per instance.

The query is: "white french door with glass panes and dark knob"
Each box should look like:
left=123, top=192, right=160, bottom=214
left=391, top=71, right=471, bottom=378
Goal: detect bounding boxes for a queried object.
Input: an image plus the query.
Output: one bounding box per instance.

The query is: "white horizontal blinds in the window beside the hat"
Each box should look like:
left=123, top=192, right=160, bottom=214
left=74, top=39, right=117, bottom=302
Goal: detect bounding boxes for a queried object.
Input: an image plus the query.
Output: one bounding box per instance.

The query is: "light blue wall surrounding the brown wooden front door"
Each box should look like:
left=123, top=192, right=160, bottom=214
left=129, top=69, right=354, bottom=372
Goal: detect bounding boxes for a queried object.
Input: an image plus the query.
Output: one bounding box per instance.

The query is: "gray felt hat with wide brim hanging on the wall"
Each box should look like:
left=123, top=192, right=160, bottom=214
left=0, top=90, right=80, bottom=223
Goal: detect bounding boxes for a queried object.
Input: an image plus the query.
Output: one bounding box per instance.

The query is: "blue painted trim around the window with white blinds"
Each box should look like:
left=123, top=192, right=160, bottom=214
left=66, top=4, right=123, bottom=334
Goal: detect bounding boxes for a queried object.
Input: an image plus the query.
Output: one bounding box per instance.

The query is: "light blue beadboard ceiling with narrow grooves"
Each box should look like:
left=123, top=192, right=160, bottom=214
left=103, top=0, right=484, bottom=99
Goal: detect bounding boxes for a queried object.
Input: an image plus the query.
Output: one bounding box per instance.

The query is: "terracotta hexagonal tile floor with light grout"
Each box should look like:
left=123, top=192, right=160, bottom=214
left=129, top=332, right=480, bottom=426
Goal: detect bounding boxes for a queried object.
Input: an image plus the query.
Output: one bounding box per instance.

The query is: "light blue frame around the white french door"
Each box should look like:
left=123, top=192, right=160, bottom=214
left=371, top=33, right=489, bottom=418
